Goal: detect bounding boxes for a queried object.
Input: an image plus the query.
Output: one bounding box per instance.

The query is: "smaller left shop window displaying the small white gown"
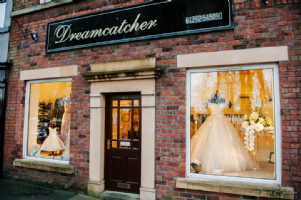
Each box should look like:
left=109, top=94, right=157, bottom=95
left=24, top=79, right=72, bottom=161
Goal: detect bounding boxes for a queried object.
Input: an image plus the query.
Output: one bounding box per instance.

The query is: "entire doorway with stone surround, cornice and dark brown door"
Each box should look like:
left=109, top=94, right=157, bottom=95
left=83, top=58, right=157, bottom=199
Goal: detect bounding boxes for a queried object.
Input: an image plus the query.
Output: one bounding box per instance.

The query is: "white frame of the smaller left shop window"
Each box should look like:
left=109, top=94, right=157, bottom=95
left=23, top=78, right=72, bottom=164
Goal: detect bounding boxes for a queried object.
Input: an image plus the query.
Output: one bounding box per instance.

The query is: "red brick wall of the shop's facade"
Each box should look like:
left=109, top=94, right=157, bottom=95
left=4, top=0, right=301, bottom=200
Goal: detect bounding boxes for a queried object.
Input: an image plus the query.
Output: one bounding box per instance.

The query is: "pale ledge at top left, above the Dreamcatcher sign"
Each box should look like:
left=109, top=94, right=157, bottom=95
left=10, top=0, right=73, bottom=17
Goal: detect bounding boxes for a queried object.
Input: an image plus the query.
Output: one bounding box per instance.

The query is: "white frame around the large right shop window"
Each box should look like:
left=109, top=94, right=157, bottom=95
left=186, top=63, right=282, bottom=185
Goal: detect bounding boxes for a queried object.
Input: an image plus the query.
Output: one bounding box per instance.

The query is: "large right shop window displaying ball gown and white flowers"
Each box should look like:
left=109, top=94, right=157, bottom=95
left=187, top=65, right=281, bottom=182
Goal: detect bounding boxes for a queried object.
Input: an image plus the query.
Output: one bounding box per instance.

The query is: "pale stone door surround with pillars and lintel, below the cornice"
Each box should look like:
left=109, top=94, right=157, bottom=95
left=88, top=78, right=156, bottom=199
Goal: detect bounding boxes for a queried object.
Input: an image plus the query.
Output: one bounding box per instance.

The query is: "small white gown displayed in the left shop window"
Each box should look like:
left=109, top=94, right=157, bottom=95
left=41, top=128, right=66, bottom=151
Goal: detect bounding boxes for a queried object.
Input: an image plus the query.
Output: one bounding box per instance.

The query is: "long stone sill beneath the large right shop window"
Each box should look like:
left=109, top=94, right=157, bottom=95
left=176, top=177, right=294, bottom=199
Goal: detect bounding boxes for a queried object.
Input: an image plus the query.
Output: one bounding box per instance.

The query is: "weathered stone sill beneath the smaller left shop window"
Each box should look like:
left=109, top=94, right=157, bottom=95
left=14, top=159, right=74, bottom=174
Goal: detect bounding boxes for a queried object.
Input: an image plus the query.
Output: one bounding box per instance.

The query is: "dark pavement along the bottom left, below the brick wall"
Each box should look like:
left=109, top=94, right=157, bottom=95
left=0, top=179, right=99, bottom=200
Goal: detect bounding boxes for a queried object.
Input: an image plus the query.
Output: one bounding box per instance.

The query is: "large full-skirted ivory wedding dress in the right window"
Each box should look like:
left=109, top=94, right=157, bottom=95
left=191, top=103, right=255, bottom=173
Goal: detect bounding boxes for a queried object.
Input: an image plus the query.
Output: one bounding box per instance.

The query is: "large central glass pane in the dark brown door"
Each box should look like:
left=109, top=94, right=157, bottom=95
left=119, top=108, right=132, bottom=139
